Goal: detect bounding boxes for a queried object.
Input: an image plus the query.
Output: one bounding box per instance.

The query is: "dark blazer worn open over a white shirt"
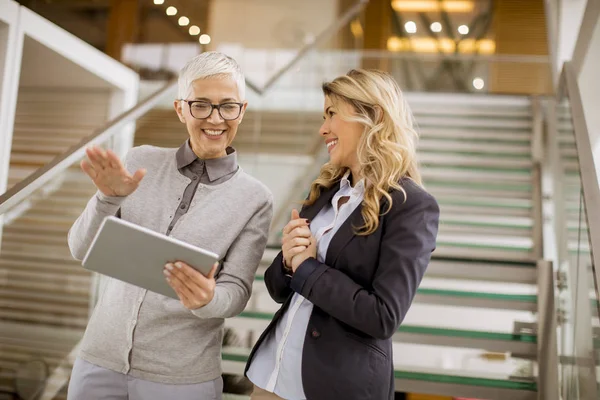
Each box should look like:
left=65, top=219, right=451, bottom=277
left=246, top=179, right=439, bottom=400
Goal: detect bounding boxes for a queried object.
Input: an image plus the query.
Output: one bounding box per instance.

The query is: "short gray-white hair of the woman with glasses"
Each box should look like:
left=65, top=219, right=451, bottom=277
left=179, top=51, right=246, bottom=100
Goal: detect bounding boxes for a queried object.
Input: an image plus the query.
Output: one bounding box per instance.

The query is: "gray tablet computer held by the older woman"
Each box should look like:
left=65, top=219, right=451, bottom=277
left=83, top=216, right=219, bottom=299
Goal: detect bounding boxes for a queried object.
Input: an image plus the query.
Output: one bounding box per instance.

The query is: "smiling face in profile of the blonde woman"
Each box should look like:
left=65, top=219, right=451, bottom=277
left=319, top=96, right=364, bottom=177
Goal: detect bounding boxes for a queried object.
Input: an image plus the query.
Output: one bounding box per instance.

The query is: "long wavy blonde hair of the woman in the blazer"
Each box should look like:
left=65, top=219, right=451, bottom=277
left=304, top=69, right=423, bottom=235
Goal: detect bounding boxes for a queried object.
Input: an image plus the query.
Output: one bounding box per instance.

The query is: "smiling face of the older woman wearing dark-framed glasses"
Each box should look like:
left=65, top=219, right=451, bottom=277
left=174, top=75, right=248, bottom=159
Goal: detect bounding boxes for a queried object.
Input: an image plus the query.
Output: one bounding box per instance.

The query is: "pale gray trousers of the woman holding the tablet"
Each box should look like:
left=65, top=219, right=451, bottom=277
left=67, top=358, right=223, bottom=400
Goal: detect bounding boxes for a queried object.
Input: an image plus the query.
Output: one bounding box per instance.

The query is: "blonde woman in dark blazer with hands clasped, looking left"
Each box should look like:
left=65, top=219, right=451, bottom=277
left=246, top=70, right=439, bottom=400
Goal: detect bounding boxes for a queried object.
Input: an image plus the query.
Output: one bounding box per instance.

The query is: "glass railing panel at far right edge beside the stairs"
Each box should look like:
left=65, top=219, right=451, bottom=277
left=556, top=95, right=600, bottom=399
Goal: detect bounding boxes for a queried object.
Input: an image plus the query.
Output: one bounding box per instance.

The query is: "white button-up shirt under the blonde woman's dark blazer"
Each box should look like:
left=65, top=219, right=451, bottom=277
left=247, top=173, right=364, bottom=400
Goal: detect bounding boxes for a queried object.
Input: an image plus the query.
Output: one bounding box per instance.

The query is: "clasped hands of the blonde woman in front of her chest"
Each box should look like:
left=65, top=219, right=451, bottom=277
left=281, top=210, right=317, bottom=272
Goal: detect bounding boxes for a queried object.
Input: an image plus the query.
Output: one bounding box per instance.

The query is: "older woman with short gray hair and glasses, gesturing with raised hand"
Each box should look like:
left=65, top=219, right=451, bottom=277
left=68, top=52, right=272, bottom=400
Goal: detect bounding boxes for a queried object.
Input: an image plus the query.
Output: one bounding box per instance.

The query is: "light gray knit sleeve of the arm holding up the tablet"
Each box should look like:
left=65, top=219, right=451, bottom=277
left=192, top=196, right=273, bottom=318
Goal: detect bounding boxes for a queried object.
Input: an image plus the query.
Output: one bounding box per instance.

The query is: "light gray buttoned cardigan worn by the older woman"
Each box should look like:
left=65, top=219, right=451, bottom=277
left=69, top=146, right=273, bottom=384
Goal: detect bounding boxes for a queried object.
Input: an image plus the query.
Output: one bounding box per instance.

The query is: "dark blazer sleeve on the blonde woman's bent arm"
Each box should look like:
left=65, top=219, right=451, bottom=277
left=291, top=195, right=439, bottom=339
